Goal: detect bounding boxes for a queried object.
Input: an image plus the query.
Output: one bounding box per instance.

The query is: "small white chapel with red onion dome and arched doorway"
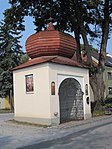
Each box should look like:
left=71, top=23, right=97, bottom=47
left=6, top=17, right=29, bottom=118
left=13, top=22, right=91, bottom=125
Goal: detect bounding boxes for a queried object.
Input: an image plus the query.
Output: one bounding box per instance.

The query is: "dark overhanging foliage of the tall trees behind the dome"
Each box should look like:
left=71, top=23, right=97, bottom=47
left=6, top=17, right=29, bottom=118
left=0, top=0, right=112, bottom=102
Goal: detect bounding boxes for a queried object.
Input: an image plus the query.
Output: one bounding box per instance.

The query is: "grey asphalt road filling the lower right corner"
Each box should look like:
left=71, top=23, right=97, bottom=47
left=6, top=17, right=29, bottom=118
left=18, top=122, right=112, bottom=149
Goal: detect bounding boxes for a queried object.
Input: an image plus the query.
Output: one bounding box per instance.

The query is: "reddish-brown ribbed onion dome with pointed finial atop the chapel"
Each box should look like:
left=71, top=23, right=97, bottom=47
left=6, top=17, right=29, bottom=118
left=26, top=22, right=77, bottom=58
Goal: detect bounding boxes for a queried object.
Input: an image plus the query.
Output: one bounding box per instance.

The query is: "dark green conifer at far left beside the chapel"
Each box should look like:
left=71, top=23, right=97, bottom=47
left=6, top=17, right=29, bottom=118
left=0, top=18, right=23, bottom=108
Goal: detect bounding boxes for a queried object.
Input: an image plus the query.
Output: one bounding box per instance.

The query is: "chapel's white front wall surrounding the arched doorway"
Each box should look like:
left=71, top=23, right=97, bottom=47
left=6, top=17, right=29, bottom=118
left=49, top=64, right=91, bottom=121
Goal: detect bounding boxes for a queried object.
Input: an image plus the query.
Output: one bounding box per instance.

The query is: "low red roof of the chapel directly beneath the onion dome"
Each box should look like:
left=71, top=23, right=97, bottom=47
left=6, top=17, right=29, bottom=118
left=12, top=56, right=88, bottom=70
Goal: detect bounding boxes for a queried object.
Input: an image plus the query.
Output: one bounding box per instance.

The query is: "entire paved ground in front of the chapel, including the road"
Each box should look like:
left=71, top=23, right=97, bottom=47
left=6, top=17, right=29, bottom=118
left=0, top=114, right=112, bottom=149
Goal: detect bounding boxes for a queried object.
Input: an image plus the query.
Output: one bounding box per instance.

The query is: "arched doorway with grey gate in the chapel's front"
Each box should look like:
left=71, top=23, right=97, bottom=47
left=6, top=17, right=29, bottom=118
left=59, top=78, right=84, bottom=123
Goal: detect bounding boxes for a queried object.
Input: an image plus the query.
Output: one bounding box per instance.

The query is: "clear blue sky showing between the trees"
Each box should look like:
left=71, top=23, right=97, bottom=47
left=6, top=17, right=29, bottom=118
left=0, top=0, right=112, bottom=55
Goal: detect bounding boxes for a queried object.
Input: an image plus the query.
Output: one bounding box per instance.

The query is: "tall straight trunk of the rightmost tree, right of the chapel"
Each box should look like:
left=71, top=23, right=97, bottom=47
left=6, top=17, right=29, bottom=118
left=97, top=0, right=109, bottom=100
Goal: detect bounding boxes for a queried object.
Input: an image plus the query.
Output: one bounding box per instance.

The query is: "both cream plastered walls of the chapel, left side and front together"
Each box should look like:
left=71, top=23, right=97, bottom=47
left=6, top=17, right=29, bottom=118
left=13, top=63, right=91, bottom=125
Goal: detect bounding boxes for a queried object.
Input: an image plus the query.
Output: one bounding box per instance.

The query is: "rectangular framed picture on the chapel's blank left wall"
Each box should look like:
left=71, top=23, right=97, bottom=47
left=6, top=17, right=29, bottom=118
left=25, top=74, right=34, bottom=93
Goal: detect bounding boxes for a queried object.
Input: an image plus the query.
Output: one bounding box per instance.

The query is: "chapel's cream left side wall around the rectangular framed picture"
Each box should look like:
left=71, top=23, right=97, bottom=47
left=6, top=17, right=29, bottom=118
left=13, top=64, right=51, bottom=122
